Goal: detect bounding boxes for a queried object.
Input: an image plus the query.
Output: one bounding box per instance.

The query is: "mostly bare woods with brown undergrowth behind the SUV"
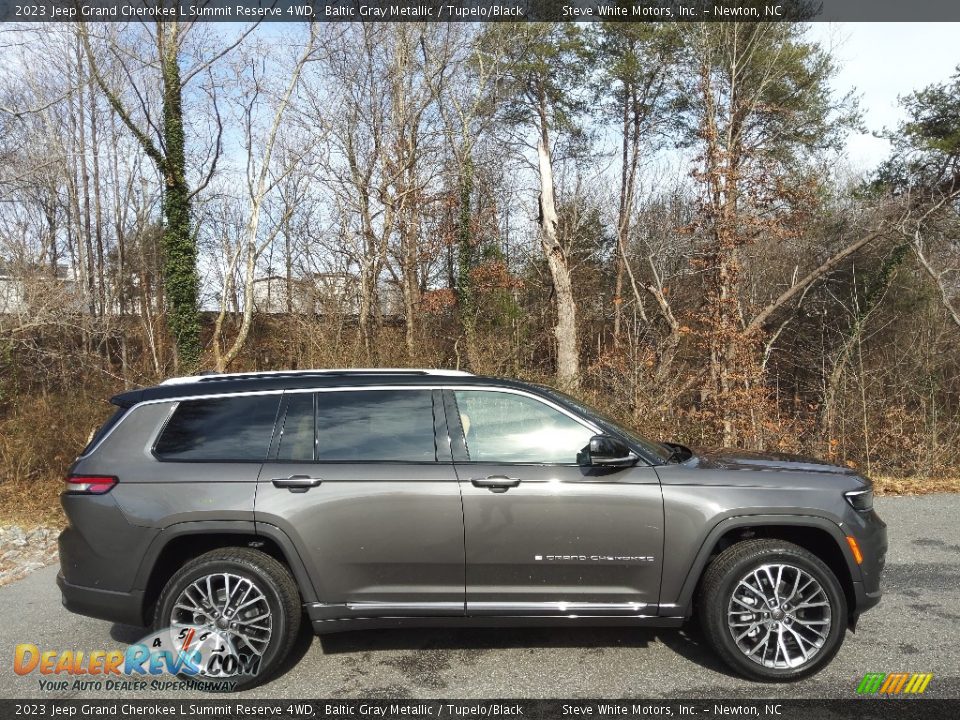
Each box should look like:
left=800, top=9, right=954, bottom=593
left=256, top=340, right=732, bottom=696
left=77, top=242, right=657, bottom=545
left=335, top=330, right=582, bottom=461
left=0, top=23, right=960, bottom=516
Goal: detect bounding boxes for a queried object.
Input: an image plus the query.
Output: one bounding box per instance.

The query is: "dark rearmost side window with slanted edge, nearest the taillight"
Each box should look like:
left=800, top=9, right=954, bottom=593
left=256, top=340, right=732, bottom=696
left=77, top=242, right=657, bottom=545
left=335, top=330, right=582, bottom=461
left=154, top=395, right=280, bottom=461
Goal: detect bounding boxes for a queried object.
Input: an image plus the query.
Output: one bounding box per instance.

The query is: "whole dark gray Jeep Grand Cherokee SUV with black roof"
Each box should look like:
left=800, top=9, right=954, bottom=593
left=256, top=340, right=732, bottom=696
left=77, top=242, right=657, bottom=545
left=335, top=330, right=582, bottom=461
left=58, top=370, right=887, bottom=684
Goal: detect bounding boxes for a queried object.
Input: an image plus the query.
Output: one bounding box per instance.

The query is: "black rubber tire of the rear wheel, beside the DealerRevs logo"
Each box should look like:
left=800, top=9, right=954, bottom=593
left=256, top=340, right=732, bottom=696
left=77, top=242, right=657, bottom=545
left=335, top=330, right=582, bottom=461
left=153, top=547, right=302, bottom=690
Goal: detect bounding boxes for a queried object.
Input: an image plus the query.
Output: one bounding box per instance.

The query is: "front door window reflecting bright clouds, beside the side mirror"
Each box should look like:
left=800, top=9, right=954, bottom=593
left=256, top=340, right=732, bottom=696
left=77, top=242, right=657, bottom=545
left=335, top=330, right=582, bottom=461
left=454, top=390, right=593, bottom=464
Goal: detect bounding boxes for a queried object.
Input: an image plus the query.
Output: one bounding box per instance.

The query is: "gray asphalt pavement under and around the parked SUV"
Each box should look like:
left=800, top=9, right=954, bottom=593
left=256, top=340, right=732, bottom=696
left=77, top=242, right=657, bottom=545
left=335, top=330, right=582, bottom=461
left=0, top=495, right=960, bottom=699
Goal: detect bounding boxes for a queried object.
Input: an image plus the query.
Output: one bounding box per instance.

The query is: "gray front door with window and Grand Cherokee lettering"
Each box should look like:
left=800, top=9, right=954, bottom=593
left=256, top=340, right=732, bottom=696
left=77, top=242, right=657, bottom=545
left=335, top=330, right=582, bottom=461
left=447, top=389, right=663, bottom=616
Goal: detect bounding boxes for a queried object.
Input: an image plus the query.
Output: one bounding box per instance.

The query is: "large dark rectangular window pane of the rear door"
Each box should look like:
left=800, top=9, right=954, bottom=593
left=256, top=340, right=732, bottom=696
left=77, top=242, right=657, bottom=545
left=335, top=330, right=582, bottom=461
left=317, top=390, right=436, bottom=462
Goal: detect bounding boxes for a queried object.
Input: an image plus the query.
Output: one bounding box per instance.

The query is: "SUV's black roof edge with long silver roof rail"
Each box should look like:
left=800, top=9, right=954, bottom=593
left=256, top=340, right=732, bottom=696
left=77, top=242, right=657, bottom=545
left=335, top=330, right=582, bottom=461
left=110, top=370, right=535, bottom=408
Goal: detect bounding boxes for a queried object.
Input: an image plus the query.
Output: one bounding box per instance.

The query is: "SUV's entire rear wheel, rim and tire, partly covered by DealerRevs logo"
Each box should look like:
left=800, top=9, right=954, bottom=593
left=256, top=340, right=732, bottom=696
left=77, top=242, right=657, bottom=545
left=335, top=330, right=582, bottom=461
left=153, top=548, right=301, bottom=689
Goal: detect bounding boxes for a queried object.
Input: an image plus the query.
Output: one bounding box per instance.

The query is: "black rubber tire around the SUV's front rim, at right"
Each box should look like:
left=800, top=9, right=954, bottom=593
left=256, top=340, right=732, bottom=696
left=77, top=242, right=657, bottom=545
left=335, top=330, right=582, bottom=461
left=697, top=539, right=847, bottom=682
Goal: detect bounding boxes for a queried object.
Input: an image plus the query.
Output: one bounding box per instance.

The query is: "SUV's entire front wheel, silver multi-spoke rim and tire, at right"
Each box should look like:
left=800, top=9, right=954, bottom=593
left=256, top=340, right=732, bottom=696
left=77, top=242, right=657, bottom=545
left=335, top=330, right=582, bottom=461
left=698, top=539, right=847, bottom=682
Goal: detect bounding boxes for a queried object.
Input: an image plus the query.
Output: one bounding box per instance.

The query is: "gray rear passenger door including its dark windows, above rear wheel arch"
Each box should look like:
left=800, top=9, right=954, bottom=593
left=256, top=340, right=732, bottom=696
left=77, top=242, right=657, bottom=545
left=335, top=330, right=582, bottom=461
left=255, top=387, right=464, bottom=617
